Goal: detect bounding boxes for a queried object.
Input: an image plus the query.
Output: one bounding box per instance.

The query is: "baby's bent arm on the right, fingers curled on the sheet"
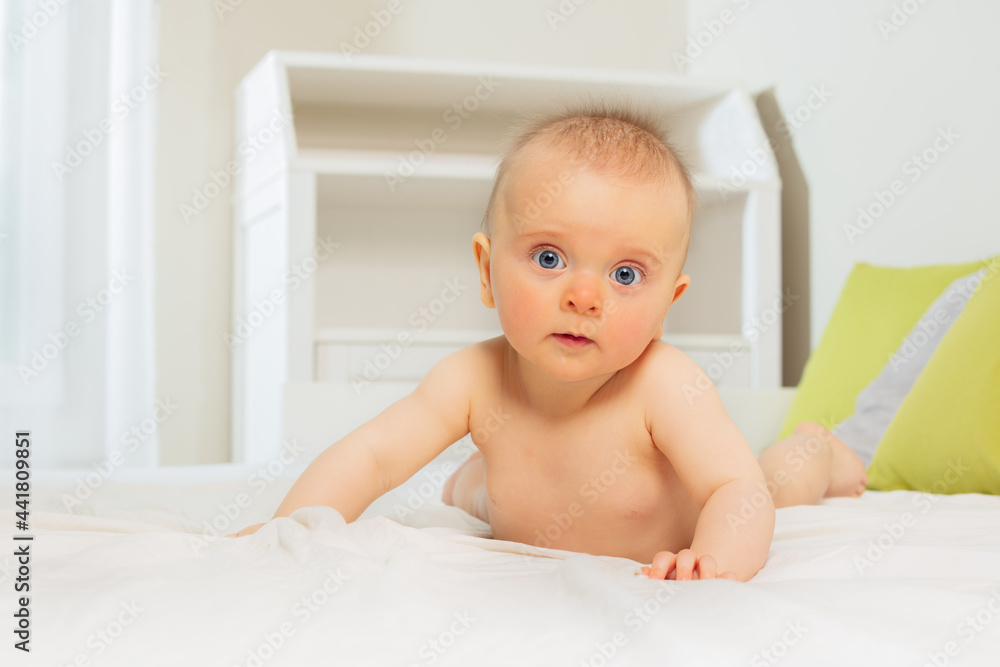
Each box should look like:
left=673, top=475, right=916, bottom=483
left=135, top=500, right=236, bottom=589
left=646, top=346, right=775, bottom=581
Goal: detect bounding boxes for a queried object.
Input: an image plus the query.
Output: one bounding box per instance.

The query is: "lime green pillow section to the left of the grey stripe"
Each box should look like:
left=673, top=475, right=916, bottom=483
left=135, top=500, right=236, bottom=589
left=779, top=259, right=990, bottom=439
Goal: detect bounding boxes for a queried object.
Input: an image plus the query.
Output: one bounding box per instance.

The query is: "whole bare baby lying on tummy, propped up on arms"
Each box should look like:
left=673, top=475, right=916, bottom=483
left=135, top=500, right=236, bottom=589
left=229, top=108, right=867, bottom=581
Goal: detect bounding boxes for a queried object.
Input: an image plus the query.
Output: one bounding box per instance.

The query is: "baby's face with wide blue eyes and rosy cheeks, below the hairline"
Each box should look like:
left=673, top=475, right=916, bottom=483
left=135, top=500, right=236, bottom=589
left=474, top=153, right=690, bottom=381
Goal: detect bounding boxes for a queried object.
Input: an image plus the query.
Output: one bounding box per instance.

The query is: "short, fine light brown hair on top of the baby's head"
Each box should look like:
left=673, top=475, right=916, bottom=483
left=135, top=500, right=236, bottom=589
left=483, top=102, right=697, bottom=254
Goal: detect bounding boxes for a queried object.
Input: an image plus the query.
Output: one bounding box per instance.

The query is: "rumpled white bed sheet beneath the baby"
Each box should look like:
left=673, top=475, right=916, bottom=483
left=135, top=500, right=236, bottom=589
left=0, top=467, right=1000, bottom=667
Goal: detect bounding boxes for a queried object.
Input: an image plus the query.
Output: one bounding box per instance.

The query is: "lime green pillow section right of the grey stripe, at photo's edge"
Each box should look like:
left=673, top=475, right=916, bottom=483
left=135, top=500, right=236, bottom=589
left=868, top=266, right=1000, bottom=494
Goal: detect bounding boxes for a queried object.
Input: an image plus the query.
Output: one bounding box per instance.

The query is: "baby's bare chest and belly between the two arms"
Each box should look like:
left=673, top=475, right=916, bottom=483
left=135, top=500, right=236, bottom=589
left=469, top=339, right=698, bottom=562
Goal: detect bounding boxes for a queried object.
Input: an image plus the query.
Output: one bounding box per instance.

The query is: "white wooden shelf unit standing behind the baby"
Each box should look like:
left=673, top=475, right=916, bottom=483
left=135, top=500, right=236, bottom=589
left=230, top=51, right=782, bottom=462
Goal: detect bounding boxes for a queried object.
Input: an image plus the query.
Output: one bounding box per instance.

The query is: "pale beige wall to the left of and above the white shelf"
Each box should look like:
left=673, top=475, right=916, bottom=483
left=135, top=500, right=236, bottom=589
left=156, top=0, right=686, bottom=465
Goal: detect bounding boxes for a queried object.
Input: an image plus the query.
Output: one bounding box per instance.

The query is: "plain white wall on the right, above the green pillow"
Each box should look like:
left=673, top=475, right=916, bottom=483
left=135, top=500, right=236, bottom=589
left=688, top=0, right=1000, bottom=352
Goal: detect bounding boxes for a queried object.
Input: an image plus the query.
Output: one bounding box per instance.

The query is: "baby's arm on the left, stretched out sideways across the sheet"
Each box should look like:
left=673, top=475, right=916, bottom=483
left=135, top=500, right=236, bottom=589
left=229, top=346, right=479, bottom=536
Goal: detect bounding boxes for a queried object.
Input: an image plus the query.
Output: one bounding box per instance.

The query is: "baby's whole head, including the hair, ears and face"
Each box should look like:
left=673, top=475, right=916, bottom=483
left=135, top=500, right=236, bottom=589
left=473, top=107, right=695, bottom=380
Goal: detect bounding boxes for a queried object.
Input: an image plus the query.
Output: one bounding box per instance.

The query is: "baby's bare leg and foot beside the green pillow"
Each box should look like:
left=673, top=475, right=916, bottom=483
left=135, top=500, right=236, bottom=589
left=757, top=422, right=868, bottom=507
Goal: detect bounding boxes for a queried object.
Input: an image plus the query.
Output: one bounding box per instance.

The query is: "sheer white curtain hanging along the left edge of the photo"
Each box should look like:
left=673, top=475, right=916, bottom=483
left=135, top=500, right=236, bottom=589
left=0, top=0, right=158, bottom=470
